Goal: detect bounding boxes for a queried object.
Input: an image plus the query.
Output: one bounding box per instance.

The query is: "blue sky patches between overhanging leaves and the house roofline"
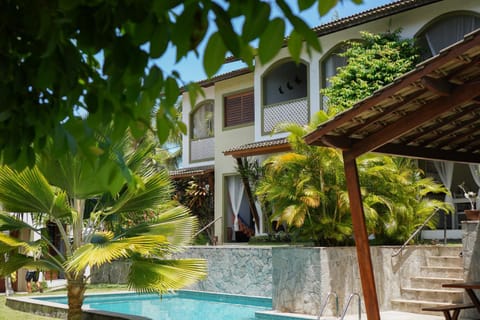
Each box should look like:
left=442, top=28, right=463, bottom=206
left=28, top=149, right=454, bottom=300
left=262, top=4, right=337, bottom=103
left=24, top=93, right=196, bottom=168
left=158, top=0, right=394, bottom=83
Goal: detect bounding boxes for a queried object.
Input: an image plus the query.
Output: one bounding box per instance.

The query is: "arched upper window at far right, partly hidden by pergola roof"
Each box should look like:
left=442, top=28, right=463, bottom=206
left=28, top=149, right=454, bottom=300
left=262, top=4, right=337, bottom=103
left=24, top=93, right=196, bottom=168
left=416, top=12, right=480, bottom=59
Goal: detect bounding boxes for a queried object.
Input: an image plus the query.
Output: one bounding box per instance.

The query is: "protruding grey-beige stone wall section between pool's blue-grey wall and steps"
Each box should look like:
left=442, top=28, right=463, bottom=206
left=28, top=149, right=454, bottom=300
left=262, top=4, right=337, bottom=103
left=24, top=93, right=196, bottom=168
left=272, top=246, right=461, bottom=315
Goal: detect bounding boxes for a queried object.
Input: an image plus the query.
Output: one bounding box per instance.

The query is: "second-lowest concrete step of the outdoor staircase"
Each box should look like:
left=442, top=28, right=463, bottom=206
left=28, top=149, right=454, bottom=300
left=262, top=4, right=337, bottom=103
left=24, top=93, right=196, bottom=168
left=400, top=288, right=463, bottom=303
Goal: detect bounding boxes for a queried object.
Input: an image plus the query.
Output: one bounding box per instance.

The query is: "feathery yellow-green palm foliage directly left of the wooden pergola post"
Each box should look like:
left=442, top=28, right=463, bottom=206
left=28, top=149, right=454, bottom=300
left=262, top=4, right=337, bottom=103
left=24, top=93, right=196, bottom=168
left=257, top=112, right=352, bottom=245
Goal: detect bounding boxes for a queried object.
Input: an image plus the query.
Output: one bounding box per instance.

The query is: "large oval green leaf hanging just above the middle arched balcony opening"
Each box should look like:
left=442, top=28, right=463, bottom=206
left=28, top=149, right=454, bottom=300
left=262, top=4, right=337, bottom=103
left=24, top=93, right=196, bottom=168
left=258, top=18, right=285, bottom=64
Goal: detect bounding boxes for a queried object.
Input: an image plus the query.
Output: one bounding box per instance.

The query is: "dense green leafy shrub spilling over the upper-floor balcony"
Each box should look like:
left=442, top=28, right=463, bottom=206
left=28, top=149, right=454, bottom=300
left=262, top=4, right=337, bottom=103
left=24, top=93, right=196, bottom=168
left=321, top=30, right=420, bottom=114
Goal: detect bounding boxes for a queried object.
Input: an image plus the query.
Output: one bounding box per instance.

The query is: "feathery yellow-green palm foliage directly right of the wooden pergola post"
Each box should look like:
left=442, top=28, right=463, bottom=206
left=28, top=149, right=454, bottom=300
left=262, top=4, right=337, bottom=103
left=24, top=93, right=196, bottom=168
left=358, top=155, right=453, bottom=244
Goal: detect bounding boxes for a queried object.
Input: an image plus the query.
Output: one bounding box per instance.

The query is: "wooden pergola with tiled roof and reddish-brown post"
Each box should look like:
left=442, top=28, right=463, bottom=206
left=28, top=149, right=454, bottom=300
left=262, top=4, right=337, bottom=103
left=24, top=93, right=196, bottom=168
left=305, top=30, right=480, bottom=320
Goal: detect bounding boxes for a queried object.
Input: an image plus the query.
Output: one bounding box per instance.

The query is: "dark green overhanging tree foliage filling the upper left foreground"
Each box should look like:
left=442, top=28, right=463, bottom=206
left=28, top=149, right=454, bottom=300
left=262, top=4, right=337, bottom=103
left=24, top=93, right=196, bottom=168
left=0, top=0, right=360, bottom=172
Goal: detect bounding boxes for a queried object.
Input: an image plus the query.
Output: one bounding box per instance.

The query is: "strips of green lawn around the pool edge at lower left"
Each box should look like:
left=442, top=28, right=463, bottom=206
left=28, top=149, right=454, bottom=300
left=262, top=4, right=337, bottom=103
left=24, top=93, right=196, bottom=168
left=0, top=284, right=127, bottom=320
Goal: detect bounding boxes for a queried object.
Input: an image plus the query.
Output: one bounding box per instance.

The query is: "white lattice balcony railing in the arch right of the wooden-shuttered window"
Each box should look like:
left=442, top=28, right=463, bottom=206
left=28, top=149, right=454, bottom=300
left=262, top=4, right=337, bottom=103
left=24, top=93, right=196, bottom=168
left=262, top=97, right=309, bottom=133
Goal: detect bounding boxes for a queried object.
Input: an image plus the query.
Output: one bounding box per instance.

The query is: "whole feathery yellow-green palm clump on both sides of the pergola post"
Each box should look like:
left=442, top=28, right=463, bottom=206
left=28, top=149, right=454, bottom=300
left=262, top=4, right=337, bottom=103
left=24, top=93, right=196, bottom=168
left=257, top=112, right=452, bottom=245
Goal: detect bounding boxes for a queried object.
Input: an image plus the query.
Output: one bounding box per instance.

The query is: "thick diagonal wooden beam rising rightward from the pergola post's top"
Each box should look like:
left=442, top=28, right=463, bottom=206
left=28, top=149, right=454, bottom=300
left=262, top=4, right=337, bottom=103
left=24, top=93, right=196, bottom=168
left=346, top=81, right=480, bottom=160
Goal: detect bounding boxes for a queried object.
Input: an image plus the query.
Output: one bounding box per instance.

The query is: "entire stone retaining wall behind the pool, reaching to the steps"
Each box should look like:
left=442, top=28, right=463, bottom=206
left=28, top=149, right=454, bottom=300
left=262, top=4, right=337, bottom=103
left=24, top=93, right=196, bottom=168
left=92, top=245, right=461, bottom=315
